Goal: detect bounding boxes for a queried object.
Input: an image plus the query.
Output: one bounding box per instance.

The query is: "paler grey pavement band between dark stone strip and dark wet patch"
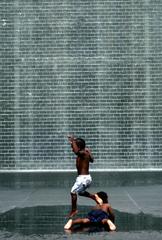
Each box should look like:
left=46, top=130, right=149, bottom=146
left=0, top=184, right=162, bottom=217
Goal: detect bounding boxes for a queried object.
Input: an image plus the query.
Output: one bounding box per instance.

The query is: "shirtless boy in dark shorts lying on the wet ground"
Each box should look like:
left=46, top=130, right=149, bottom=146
left=64, top=192, right=116, bottom=231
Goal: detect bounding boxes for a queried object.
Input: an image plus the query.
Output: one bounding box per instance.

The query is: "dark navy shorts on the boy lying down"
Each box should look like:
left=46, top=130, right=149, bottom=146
left=87, top=209, right=109, bottom=223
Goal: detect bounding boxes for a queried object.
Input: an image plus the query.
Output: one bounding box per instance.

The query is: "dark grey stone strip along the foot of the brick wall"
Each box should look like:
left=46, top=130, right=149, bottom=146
left=0, top=171, right=162, bottom=187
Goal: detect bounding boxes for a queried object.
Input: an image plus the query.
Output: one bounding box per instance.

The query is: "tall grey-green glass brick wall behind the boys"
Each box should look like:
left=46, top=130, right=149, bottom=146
left=0, top=0, right=162, bottom=170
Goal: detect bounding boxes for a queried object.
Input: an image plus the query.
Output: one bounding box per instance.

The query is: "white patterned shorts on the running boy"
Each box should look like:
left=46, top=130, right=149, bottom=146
left=71, top=174, right=92, bottom=193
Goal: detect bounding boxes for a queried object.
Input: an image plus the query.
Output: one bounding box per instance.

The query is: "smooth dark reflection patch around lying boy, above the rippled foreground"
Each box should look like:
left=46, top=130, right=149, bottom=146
left=0, top=206, right=162, bottom=235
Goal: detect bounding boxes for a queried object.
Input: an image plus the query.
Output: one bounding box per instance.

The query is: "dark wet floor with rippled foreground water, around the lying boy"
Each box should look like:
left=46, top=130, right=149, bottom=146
left=0, top=206, right=162, bottom=240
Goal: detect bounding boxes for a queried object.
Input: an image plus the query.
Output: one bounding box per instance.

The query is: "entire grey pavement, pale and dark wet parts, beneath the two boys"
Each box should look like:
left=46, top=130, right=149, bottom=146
left=0, top=184, right=162, bottom=240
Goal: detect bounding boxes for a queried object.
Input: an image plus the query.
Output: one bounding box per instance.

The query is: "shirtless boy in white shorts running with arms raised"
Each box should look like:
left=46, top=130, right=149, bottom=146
left=68, top=136, right=102, bottom=217
